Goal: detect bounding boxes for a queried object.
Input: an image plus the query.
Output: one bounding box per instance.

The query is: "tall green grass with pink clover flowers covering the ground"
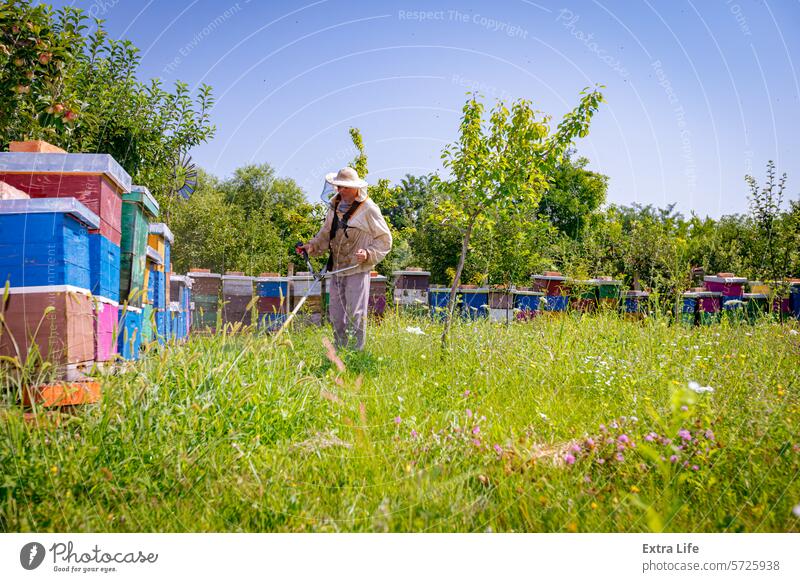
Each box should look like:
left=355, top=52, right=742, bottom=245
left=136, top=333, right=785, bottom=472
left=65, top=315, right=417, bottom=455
left=0, top=314, right=800, bottom=532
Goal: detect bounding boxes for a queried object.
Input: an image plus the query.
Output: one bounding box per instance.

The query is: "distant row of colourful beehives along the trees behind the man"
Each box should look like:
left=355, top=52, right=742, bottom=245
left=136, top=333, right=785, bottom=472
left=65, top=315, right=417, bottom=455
left=178, top=269, right=800, bottom=331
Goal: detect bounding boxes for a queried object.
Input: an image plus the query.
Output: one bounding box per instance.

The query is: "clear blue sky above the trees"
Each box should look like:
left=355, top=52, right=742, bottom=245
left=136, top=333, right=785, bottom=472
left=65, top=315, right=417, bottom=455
left=47, top=0, right=800, bottom=216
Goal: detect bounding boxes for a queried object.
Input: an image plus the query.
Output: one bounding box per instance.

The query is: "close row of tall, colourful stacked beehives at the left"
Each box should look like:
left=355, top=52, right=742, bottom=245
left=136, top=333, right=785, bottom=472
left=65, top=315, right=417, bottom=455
left=0, top=142, right=191, bottom=406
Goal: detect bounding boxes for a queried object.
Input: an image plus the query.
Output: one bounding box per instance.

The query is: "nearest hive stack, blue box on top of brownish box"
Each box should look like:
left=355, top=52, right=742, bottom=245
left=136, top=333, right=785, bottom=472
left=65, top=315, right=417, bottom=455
left=0, top=198, right=100, bottom=376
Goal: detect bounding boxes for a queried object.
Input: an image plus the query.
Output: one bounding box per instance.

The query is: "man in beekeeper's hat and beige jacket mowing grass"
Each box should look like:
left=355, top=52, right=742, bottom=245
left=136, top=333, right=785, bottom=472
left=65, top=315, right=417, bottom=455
left=298, top=168, right=392, bottom=350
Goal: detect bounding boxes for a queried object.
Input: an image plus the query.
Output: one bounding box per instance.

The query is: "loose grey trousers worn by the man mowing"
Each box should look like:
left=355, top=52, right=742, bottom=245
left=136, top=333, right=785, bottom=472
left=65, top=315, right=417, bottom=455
left=328, top=272, right=369, bottom=350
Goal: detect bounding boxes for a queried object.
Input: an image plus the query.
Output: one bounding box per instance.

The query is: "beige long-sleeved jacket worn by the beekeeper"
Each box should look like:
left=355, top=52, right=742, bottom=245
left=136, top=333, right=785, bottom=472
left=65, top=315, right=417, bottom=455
left=308, top=198, right=392, bottom=276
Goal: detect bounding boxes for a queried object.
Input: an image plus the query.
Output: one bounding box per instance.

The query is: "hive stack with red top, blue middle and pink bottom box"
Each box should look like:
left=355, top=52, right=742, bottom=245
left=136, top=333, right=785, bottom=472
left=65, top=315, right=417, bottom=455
left=0, top=152, right=131, bottom=368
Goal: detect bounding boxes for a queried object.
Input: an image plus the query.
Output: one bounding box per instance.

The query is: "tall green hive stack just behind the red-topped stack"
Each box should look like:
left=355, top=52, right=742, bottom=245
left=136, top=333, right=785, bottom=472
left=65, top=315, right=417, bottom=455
left=119, top=186, right=159, bottom=307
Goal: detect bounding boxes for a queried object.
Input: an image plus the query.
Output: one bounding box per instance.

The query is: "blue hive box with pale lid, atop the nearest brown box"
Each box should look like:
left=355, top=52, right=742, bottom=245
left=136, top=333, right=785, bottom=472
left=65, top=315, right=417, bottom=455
left=0, top=198, right=100, bottom=289
